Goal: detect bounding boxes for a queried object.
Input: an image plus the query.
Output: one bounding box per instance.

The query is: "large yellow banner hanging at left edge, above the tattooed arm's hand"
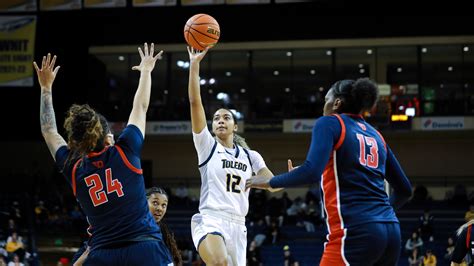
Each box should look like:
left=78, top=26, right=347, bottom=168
left=0, top=16, right=36, bottom=87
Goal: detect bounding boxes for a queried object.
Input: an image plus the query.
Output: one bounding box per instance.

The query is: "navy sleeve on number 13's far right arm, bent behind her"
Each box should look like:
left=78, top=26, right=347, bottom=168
left=385, top=146, right=412, bottom=209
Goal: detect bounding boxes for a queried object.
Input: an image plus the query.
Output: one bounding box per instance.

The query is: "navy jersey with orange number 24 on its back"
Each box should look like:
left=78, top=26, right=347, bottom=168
left=56, top=125, right=161, bottom=249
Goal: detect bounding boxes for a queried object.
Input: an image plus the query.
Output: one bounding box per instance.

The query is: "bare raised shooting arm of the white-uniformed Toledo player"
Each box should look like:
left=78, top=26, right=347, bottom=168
left=188, top=47, right=209, bottom=133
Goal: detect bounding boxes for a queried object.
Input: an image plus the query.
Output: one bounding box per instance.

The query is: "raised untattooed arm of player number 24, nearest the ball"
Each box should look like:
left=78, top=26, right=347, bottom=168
left=128, top=43, right=163, bottom=137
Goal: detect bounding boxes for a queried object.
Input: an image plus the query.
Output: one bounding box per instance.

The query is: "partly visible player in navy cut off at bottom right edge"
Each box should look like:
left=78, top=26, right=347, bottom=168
left=451, top=220, right=474, bottom=266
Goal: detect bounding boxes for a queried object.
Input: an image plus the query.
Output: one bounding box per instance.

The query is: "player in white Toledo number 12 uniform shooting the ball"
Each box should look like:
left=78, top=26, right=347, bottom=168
left=188, top=47, right=280, bottom=266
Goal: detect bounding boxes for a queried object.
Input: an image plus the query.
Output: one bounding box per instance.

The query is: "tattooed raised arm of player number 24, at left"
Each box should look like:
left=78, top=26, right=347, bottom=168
left=33, top=53, right=66, bottom=158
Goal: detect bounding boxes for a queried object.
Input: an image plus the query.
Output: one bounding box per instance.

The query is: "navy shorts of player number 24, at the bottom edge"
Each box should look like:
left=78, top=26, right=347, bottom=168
left=83, top=240, right=173, bottom=266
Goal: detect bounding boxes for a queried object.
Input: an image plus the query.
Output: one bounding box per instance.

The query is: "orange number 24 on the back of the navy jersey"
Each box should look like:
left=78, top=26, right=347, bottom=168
left=84, top=168, right=123, bottom=207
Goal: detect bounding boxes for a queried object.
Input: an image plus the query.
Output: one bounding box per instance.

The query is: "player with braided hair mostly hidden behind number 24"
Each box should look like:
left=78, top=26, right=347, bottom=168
left=72, top=187, right=183, bottom=266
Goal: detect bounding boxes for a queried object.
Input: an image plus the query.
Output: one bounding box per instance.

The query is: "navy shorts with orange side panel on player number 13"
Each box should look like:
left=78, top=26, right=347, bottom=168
left=320, top=223, right=401, bottom=266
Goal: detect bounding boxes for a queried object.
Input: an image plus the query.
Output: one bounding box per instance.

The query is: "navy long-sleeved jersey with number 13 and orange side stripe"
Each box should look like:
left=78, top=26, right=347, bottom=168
left=270, top=114, right=411, bottom=229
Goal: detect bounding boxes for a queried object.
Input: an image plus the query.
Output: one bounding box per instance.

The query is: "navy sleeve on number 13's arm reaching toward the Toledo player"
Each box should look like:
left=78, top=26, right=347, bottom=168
left=270, top=116, right=341, bottom=188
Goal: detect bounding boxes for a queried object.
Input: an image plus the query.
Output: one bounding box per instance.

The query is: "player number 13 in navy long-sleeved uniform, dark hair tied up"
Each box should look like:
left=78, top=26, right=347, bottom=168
left=246, top=78, right=412, bottom=266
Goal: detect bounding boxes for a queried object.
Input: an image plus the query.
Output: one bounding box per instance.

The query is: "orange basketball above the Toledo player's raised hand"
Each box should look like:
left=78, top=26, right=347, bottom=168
left=184, top=14, right=221, bottom=51
